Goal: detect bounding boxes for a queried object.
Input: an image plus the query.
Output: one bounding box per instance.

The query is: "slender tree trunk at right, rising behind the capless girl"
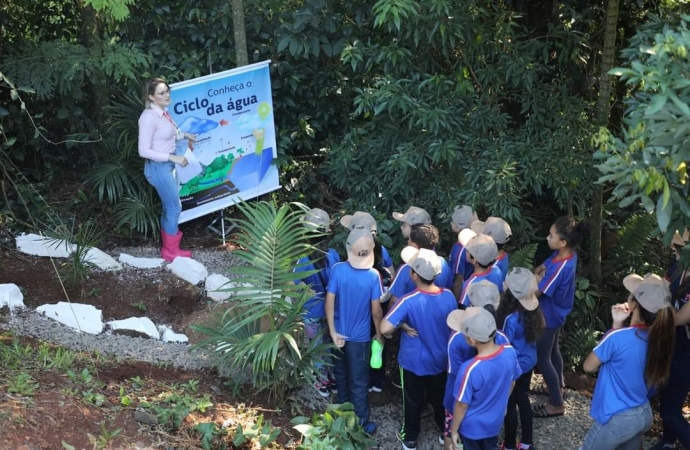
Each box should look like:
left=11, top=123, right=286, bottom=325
left=589, top=0, right=620, bottom=286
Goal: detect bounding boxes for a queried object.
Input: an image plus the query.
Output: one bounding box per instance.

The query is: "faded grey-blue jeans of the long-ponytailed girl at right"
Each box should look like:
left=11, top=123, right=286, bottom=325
left=580, top=403, right=652, bottom=450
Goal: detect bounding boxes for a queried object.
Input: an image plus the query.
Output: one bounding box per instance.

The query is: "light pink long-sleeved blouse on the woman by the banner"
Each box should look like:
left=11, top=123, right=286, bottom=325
left=139, top=104, right=184, bottom=162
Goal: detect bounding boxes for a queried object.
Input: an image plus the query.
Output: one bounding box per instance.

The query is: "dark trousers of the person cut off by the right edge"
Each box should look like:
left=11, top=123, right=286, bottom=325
left=659, top=326, right=690, bottom=449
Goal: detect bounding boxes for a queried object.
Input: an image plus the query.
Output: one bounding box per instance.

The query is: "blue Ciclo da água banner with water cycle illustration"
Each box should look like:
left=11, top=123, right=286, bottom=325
left=168, top=61, right=280, bottom=223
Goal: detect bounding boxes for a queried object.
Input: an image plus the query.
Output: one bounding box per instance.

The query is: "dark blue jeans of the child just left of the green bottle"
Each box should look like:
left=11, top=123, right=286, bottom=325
left=333, top=341, right=371, bottom=424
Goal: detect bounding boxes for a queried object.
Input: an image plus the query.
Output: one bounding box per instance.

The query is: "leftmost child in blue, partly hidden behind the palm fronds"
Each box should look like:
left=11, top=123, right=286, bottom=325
left=295, top=208, right=340, bottom=397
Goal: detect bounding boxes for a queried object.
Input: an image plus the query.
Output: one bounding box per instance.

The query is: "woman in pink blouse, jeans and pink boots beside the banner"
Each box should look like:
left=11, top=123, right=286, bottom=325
left=138, top=78, right=196, bottom=262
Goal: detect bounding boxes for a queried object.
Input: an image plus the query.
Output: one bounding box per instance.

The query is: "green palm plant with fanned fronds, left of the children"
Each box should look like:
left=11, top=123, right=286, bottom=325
left=193, top=202, right=329, bottom=403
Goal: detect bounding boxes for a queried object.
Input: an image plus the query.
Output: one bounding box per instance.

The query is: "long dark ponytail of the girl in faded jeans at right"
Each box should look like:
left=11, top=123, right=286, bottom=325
left=635, top=300, right=676, bottom=388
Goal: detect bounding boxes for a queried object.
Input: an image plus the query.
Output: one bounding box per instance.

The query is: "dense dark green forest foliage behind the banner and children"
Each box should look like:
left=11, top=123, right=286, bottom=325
left=0, top=0, right=690, bottom=376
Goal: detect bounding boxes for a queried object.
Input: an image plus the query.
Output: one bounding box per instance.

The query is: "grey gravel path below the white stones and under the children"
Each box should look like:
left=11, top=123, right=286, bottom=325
left=0, top=247, right=651, bottom=450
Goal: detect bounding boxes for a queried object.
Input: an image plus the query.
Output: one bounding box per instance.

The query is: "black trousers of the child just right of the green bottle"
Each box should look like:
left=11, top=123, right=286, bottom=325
left=400, top=367, right=447, bottom=441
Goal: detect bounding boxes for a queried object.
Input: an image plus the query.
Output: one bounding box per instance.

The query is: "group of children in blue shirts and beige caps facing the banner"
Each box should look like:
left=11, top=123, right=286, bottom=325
left=294, top=206, right=690, bottom=450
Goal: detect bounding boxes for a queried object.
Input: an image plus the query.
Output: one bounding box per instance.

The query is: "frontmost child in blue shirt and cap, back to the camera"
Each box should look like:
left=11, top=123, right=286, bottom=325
left=449, top=307, right=521, bottom=450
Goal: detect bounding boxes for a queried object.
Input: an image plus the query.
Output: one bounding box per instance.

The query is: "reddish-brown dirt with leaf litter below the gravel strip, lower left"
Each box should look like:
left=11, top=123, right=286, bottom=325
left=0, top=336, right=298, bottom=450
